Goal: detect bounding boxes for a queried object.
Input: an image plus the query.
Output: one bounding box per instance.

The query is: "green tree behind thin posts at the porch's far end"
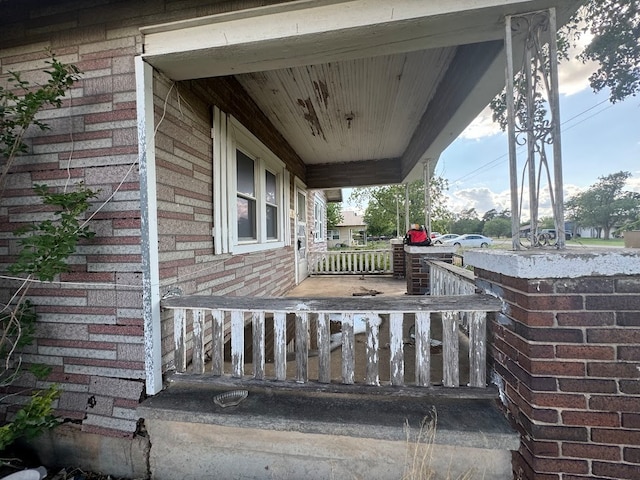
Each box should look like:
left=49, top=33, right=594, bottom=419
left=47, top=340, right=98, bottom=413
left=350, top=177, right=452, bottom=235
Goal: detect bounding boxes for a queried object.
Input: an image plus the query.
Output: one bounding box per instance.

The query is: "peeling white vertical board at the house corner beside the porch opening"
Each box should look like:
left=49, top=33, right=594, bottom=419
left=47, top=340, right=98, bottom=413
left=135, top=56, right=162, bottom=395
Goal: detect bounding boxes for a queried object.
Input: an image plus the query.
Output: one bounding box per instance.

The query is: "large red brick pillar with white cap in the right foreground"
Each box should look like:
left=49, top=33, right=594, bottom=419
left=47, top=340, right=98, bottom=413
left=465, top=250, right=640, bottom=480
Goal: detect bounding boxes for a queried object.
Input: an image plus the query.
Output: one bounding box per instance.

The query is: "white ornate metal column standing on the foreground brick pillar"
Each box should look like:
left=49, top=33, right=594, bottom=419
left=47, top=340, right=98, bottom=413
left=505, top=9, right=565, bottom=250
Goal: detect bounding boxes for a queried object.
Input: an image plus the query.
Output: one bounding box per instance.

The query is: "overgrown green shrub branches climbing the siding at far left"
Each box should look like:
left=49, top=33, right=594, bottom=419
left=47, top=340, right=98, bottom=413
left=0, top=55, right=96, bottom=450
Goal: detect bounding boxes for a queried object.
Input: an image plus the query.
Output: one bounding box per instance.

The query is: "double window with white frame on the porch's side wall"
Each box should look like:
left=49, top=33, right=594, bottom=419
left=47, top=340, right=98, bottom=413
left=212, top=109, right=290, bottom=253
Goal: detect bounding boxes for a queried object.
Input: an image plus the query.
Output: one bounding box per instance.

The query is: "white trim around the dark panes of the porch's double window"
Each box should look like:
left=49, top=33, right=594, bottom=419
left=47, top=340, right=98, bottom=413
left=212, top=108, right=291, bottom=254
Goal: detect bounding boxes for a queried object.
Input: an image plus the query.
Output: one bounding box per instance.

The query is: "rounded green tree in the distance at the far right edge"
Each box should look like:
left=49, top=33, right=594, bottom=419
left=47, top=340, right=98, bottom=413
left=565, top=172, right=640, bottom=239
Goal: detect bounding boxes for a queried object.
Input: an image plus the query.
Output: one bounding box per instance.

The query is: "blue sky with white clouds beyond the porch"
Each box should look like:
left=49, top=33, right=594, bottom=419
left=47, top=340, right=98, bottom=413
left=343, top=46, right=640, bottom=218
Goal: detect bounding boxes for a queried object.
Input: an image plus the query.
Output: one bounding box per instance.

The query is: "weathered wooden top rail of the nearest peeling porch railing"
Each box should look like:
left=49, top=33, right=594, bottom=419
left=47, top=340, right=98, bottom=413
left=161, top=294, right=502, bottom=314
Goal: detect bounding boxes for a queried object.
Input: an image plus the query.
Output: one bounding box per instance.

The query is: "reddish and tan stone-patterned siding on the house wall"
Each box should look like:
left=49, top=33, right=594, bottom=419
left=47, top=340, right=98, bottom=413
left=0, top=0, right=305, bottom=436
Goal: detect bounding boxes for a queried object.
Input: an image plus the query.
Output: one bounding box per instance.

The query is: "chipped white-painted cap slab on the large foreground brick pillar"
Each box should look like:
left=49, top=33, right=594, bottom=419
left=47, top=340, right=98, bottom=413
left=464, top=248, right=640, bottom=279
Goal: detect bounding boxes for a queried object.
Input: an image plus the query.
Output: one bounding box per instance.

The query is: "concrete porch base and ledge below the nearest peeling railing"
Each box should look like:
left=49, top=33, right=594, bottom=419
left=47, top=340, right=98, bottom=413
left=139, top=384, right=519, bottom=480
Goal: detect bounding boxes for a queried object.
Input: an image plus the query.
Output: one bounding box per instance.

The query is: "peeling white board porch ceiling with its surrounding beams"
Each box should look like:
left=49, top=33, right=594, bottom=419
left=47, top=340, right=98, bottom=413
left=142, top=0, right=579, bottom=189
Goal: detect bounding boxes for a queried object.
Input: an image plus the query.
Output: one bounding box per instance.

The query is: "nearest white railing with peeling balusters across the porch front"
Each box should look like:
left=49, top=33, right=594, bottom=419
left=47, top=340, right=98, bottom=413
left=162, top=295, right=500, bottom=387
